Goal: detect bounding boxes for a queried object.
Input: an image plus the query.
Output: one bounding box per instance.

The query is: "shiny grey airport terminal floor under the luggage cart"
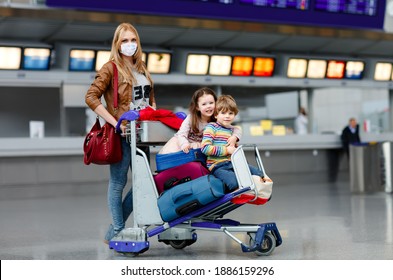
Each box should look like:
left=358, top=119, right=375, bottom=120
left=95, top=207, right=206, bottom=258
left=0, top=176, right=393, bottom=260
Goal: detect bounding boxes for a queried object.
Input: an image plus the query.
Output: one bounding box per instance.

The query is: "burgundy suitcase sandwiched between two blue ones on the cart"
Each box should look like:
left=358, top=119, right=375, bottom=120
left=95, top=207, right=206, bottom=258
left=154, top=161, right=210, bottom=194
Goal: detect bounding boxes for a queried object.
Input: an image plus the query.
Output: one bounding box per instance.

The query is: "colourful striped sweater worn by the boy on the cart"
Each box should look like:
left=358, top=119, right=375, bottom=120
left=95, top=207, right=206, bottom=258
left=201, top=122, right=234, bottom=170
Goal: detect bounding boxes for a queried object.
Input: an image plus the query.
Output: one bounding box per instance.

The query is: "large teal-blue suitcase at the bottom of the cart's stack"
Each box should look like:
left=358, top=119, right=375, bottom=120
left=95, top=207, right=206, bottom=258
left=157, top=175, right=225, bottom=222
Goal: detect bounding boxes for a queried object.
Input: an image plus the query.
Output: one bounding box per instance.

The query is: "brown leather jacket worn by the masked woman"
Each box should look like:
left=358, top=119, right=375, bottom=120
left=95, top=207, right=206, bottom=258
left=85, top=62, right=155, bottom=120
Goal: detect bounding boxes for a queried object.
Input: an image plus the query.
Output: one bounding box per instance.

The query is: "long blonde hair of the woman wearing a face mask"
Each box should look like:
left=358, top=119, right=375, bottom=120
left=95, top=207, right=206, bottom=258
left=109, top=22, right=153, bottom=87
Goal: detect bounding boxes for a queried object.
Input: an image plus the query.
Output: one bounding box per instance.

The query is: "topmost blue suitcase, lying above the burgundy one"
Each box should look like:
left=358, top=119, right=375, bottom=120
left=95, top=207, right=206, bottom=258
left=156, top=149, right=206, bottom=172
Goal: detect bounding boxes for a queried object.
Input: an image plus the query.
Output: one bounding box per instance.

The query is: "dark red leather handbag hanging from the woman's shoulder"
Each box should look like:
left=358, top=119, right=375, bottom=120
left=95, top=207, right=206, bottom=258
left=83, top=62, right=122, bottom=165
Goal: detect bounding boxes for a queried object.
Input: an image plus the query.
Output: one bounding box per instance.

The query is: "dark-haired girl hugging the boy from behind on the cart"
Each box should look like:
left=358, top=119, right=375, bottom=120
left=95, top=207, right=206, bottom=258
left=159, top=87, right=241, bottom=154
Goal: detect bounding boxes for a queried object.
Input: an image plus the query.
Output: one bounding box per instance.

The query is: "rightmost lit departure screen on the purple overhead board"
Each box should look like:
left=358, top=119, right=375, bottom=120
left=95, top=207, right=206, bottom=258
left=315, top=0, right=378, bottom=16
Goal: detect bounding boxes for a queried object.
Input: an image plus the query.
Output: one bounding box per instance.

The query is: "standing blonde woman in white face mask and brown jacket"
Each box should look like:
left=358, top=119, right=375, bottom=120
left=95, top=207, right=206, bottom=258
left=85, top=23, right=156, bottom=243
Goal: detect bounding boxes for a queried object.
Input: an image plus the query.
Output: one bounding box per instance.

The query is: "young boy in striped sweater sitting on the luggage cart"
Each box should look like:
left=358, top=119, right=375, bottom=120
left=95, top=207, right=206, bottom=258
left=201, top=95, right=271, bottom=191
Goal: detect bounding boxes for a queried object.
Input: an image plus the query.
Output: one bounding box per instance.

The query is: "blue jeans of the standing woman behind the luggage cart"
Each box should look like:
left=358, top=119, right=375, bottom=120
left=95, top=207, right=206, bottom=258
left=105, top=137, right=133, bottom=240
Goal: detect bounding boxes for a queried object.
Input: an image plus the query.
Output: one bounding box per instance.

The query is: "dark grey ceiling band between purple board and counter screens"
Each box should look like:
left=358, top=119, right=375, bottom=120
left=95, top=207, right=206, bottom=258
left=0, top=6, right=393, bottom=58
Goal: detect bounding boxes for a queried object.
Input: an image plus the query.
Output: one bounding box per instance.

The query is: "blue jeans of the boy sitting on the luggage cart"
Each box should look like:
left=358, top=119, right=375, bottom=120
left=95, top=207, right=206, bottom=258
left=211, top=161, right=263, bottom=191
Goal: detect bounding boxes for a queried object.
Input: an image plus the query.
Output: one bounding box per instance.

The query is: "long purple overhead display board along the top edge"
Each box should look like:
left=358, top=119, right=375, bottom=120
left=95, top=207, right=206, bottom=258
left=46, top=0, right=386, bottom=29
